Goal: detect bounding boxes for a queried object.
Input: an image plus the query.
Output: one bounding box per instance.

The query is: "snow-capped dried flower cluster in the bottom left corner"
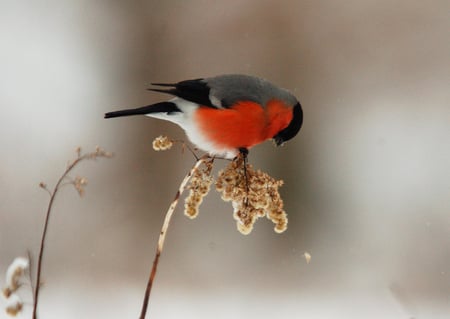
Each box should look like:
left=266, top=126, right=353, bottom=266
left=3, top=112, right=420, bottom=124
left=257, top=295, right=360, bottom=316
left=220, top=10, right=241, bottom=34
left=2, top=257, right=29, bottom=316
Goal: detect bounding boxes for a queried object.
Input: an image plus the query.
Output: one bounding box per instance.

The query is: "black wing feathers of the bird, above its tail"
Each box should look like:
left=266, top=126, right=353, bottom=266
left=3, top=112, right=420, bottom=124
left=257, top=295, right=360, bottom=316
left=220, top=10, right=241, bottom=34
left=148, top=79, right=217, bottom=108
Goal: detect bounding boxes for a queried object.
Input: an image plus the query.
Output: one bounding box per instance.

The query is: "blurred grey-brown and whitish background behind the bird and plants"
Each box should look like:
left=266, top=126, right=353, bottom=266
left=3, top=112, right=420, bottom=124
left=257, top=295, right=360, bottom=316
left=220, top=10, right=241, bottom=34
left=0, top=0, right=450, bottom=319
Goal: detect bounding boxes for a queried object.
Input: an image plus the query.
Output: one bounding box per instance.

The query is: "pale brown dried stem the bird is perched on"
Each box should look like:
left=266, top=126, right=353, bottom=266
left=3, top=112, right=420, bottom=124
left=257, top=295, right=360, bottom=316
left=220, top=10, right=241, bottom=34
left=139, top=155, right=209, bottom=319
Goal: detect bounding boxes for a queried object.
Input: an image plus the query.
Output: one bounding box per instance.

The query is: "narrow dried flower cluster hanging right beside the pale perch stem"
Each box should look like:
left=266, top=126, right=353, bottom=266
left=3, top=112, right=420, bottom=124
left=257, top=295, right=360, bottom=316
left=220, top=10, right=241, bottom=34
left=184, top=159, right=213, bottom=219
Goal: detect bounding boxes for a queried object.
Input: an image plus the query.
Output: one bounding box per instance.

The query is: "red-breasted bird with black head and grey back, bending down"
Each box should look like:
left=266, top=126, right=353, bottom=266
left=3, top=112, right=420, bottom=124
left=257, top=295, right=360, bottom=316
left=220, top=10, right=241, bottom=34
left=105, top=74, right=303, bottom=159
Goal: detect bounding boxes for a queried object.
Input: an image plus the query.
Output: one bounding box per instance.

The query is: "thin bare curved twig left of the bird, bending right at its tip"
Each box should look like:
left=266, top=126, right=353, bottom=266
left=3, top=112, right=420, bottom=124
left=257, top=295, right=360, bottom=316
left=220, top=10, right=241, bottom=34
left=32, top=147, right=112, bottom=319
